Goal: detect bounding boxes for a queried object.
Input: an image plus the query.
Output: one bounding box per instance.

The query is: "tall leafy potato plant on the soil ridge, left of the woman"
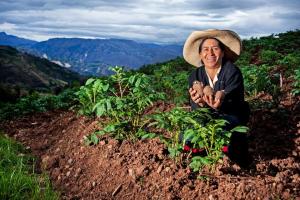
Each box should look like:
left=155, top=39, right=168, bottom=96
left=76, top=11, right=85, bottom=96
left=78, top=67, right=164, bottom=143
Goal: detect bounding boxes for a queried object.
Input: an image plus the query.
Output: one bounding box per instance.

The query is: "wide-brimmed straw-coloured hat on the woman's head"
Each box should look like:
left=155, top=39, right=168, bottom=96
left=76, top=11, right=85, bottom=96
left=183, top=29, right=242, bottom=67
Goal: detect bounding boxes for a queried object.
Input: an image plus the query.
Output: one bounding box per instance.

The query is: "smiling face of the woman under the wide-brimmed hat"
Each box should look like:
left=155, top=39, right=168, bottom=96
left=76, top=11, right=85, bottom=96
left=200, top=39, right=224, bottom=69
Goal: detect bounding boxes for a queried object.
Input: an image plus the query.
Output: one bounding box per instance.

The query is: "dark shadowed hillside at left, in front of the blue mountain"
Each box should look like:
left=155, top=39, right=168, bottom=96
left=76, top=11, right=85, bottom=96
left=0, top=46, right=82, bottom=95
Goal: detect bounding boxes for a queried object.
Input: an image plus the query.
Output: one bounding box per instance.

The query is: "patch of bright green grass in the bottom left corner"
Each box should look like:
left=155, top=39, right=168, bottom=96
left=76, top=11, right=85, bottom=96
left=0, top=131, right=59, bottom=200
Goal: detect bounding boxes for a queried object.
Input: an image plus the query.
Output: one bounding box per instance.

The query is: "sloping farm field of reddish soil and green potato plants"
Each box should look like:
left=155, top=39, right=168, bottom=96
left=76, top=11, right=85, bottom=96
left=0, top=31, right=300, bottom=199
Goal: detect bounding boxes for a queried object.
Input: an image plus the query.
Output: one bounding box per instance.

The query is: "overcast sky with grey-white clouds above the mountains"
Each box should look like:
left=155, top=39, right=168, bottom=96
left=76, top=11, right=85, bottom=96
left=0, top=0, right=300, bottom=44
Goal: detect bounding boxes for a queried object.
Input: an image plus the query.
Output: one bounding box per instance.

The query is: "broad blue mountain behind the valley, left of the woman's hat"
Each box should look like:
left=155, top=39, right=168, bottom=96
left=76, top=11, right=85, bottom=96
left=0, top=32, right=182, bottom=75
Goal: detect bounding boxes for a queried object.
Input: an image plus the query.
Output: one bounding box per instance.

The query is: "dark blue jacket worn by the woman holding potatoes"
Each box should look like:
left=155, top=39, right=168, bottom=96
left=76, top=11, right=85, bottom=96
left=189, top=61, right=250, bottom=124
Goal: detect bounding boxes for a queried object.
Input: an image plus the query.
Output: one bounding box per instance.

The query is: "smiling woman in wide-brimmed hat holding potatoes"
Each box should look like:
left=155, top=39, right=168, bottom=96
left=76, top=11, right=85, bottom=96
left=183, top=30, right=250, bottom=164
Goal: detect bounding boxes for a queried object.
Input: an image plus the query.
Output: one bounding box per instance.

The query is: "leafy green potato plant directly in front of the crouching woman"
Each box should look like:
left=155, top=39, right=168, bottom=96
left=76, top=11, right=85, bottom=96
left=145, top=108, right=248, bottom=171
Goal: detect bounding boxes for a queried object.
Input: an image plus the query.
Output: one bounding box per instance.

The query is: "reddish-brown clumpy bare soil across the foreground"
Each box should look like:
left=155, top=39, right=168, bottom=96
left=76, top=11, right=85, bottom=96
left=0, top=97, right=300, bottom=200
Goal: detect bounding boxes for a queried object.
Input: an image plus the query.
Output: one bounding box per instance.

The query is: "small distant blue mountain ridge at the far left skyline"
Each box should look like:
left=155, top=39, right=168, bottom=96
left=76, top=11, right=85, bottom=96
left=0, top=32, right=37, bottom=47
